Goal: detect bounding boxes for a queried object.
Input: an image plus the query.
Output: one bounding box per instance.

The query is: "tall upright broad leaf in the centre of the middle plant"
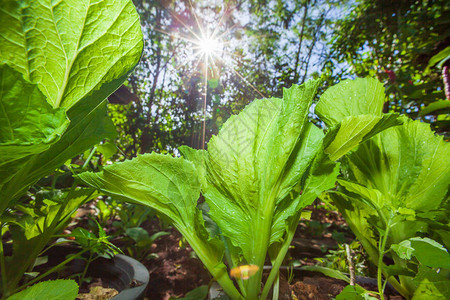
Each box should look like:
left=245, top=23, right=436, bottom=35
left=181, top=82, right=323, bottom=262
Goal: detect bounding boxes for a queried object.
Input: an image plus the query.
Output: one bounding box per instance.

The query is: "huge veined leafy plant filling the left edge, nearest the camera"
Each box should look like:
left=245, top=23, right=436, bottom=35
left=0, top=0, right=143, bottom=297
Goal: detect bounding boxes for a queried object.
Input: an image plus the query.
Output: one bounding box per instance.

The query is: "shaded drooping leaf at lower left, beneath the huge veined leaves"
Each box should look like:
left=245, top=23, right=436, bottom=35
left=1, top=188, right=98, bottom=287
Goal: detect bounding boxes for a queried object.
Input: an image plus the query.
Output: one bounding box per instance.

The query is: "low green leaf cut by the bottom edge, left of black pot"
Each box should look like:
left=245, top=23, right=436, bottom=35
left=8, top=280, right=78, bottom=300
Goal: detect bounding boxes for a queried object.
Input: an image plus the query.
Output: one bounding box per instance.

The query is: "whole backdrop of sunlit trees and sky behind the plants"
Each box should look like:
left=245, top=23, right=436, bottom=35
left=110, top=0, right=450, bottom=158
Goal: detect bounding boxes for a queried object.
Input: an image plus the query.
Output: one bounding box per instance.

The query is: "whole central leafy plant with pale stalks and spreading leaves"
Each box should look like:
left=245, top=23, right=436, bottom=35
left=79, top=79, right=401, bottom=299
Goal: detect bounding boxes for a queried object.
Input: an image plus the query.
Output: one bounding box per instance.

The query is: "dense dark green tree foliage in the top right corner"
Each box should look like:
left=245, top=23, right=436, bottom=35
left=327, top=0, right=450, bottom=131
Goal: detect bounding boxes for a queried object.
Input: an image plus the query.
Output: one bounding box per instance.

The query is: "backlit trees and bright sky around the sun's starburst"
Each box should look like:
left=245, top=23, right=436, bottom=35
left=110, top=0, right=344, bottom=157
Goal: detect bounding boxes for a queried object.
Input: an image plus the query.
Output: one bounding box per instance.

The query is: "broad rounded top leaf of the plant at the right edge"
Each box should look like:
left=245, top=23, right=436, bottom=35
left=342, top=121, right=450, bottom=211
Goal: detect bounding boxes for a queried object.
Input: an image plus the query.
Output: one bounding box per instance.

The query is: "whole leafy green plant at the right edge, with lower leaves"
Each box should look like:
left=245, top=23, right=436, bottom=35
left=327, top=119, right=450, bottom=299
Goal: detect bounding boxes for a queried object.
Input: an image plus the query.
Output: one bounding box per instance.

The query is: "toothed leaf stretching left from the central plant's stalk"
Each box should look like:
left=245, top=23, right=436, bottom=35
left=79, top=153, right=200, bottom=228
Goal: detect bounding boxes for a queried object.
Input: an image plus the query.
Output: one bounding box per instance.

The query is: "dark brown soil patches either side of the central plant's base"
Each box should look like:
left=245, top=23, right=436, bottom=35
left=69, top=206, right=403, bottom=300
